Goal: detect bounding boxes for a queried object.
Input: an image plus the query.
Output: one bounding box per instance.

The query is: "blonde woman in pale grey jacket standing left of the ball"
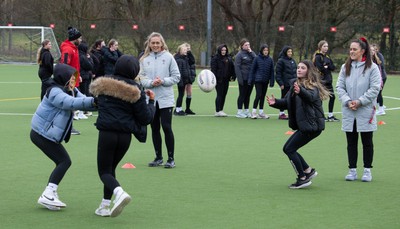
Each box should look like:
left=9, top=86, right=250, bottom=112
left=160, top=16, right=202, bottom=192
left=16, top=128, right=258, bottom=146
left=139, top=32, right=181, bottom=168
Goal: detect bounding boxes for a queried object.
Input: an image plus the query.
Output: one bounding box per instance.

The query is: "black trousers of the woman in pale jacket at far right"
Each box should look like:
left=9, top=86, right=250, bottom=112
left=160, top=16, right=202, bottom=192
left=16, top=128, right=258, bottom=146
left=346, top=121, right=374, bottom=169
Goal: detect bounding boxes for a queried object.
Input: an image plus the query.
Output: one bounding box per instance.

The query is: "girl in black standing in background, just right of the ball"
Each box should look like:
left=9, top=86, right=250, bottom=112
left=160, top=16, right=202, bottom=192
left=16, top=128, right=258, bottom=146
left=211, top=44, right=236, bottom=117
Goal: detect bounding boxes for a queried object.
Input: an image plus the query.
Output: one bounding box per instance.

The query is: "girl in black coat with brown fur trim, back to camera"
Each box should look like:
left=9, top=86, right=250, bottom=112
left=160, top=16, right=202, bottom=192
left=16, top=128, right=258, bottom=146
left=90, top=55, right=155, bottom=217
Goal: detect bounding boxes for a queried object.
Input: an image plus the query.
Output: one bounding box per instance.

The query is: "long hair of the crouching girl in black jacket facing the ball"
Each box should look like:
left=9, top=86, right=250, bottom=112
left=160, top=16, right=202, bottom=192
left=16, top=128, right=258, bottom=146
left=297, top=60, right=331, bottom=100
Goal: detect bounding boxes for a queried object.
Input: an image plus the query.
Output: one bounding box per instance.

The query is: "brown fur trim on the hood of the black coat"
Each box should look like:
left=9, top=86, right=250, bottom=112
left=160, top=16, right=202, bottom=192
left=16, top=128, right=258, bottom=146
left=89, top=77, right=140, bottom=103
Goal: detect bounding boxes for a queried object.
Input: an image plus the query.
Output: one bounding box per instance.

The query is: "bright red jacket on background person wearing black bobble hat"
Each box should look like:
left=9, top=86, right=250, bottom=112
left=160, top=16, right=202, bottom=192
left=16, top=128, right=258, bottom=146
left=60, top=40, right=81, bottom=87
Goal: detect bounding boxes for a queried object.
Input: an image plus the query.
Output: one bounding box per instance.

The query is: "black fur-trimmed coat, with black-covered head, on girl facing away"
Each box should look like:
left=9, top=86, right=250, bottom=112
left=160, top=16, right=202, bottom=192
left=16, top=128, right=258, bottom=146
left=90, top=55, right=155, bottom=133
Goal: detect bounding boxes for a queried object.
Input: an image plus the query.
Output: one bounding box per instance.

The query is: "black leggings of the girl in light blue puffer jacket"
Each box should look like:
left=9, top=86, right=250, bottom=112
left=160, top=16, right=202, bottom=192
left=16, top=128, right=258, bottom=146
left=30, top=130, right=72, bottom=185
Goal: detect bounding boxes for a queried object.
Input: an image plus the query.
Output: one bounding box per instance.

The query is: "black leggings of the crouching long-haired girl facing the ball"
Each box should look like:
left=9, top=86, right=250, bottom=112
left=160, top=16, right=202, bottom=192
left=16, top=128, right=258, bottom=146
left=283, top=130, right=322, bottom=178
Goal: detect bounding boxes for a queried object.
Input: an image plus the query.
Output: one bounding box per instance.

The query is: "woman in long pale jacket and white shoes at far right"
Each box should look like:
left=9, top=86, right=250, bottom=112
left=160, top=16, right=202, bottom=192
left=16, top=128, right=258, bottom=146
left=336, top=37, right=381, bottom=182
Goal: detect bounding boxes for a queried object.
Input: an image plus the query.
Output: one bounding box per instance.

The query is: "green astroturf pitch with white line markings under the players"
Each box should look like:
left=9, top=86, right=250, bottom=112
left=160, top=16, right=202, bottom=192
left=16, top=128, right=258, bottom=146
left=0, top=65, right=400, bottom=229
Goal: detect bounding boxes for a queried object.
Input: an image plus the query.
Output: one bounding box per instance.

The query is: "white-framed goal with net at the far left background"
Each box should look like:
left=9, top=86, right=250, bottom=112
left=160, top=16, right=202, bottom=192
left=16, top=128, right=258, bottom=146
left=0, top=26, right=61, bottom=63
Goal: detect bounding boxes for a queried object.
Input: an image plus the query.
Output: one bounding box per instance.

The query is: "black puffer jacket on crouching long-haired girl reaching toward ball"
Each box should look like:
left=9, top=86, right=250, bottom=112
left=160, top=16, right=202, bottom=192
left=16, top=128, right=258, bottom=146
left=272, top=86, right=325, bottom=132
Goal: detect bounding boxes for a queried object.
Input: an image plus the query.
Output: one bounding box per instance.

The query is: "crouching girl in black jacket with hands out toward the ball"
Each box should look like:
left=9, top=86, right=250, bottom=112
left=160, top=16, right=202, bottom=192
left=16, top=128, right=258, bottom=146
left=267, top=60, right=329, bottom=189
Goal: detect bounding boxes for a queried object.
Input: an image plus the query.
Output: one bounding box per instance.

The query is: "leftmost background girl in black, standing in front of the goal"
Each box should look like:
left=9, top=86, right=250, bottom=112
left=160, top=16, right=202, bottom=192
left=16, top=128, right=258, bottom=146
left=37, top=39, right=54, bottom=100
